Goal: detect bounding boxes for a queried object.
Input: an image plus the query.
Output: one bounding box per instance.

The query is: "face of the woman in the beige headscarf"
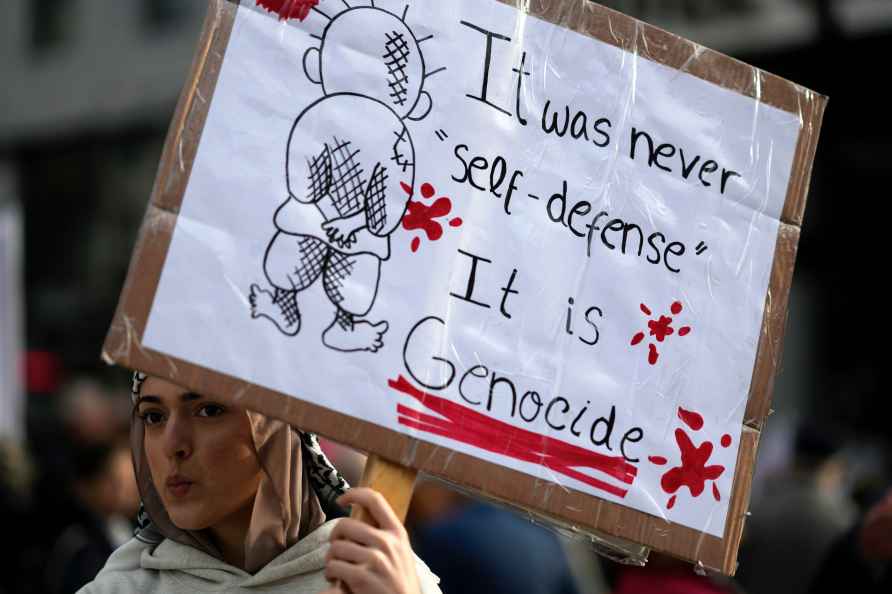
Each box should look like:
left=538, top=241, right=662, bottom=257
left=136, top=377, right=262, bottom=530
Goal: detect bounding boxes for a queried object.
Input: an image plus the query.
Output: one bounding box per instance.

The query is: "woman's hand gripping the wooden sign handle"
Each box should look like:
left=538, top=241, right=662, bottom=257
left=325, top=487, right=421, bottom=594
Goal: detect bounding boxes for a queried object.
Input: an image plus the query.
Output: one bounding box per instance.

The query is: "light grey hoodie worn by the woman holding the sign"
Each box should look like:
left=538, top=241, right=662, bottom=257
left=78, top=520, right=440, bottom=594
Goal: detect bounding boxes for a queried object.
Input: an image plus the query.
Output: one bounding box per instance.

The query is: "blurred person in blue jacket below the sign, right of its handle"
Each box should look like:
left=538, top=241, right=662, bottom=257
left=407, top=480, right=578, bottom=594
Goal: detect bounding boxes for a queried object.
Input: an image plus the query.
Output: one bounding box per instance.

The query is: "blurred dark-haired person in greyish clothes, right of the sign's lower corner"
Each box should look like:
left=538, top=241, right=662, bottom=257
left=737, top=423, right=856, bottom=594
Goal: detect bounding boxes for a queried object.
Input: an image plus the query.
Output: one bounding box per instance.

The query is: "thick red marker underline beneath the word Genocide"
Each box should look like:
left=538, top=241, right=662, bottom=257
left=387, top=375, right=638, bottom=498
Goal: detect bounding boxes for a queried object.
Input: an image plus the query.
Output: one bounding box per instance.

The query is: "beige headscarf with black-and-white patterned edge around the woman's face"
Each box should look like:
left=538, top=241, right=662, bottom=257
left=130, top=372, right=348, bottom=573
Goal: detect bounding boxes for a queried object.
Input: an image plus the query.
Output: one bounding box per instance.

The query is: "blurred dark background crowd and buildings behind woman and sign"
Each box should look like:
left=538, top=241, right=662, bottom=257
left=0, top=0, right=892, bottom=594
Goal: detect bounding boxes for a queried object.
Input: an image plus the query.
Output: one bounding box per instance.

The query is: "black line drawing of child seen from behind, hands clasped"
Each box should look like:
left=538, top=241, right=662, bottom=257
left=249, top=7, right=431, bottom=352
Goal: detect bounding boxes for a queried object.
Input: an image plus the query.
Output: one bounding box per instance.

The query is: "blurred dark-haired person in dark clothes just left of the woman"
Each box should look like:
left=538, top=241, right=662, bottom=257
left=46, top=441, right=139, bottom=594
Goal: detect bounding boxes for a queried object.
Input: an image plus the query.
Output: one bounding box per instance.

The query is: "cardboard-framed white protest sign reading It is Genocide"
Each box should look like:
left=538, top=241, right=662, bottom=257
left=106, top=0, right=824, bottom=573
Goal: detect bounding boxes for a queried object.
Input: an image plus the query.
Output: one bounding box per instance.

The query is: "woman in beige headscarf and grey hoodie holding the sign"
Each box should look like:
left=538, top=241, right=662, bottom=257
left=81, top=373, right=440, bottom=594
